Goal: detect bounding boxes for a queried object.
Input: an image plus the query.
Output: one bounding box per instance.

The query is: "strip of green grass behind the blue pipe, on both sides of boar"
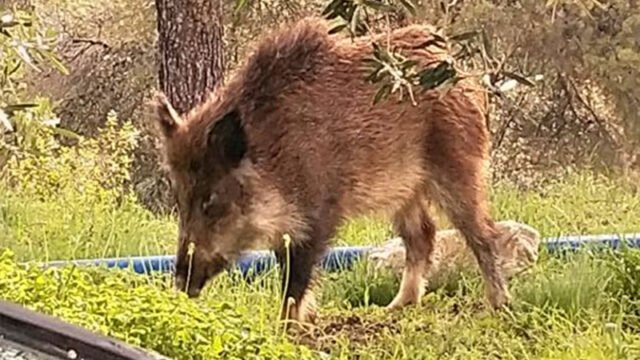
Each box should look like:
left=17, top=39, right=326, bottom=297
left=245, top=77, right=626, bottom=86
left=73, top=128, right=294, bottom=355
left=0, top=173, right=640, bottom=260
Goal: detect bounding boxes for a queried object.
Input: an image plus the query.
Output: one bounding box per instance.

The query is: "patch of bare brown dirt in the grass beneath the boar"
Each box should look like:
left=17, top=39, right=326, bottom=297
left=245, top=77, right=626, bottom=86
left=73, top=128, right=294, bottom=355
left=296, top=314, right=400, bottom=351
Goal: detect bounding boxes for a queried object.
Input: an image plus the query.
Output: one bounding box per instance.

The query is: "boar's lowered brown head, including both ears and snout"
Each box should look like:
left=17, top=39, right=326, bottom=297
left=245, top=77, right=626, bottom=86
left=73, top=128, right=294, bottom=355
left=153, top=94, right=252, bottom=297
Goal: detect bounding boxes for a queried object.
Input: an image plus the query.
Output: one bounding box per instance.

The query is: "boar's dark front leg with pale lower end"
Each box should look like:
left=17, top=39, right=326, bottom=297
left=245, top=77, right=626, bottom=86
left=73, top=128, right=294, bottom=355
left=276, top=232, right=326, bottom=323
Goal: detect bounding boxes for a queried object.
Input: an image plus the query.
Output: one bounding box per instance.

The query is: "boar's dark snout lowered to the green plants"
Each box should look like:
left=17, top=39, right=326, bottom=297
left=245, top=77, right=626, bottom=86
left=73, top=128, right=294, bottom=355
left=175, top=250, right=228, bottom=298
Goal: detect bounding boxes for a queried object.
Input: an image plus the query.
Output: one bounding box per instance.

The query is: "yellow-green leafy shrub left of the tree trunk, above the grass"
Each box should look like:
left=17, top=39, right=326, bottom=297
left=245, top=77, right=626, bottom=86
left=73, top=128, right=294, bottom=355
left=7, top=108, right=137, bottom=202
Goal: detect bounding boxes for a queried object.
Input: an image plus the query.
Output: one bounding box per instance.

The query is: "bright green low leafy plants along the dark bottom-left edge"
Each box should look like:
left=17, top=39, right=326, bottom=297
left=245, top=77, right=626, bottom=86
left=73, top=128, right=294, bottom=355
left=0, top=250, right=311, bottom=359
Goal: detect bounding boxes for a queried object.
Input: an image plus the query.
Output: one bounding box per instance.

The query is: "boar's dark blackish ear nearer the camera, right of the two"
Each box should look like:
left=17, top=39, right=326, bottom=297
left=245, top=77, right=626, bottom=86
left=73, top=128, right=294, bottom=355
left=208, top=110, right=247, bottom=169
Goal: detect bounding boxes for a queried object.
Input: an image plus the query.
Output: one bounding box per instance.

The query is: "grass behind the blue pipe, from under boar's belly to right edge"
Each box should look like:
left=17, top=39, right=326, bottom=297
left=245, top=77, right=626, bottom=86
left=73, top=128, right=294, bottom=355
left=336, top=172, right=640, bottom=249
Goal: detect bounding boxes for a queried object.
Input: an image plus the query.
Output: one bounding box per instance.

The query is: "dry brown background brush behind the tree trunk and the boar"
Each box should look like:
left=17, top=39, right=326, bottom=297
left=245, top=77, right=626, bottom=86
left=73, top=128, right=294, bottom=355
left=3, top=0, right=640, bottom=214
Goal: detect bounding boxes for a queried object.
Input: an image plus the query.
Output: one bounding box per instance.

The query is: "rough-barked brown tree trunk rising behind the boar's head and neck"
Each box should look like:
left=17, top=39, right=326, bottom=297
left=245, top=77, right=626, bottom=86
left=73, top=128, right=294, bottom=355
left=155, top=0, right=224, bottom=113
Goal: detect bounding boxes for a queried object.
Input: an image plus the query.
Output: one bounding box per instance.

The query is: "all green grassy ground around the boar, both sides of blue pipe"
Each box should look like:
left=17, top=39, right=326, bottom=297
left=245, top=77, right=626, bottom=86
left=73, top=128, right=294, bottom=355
left=0, top=170, right=640, bottom=359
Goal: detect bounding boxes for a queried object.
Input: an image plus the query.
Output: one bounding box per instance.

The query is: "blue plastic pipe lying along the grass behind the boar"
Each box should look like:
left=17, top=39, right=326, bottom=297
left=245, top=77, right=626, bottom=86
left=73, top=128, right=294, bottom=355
left=35, top=233, right=640, bottom=278
